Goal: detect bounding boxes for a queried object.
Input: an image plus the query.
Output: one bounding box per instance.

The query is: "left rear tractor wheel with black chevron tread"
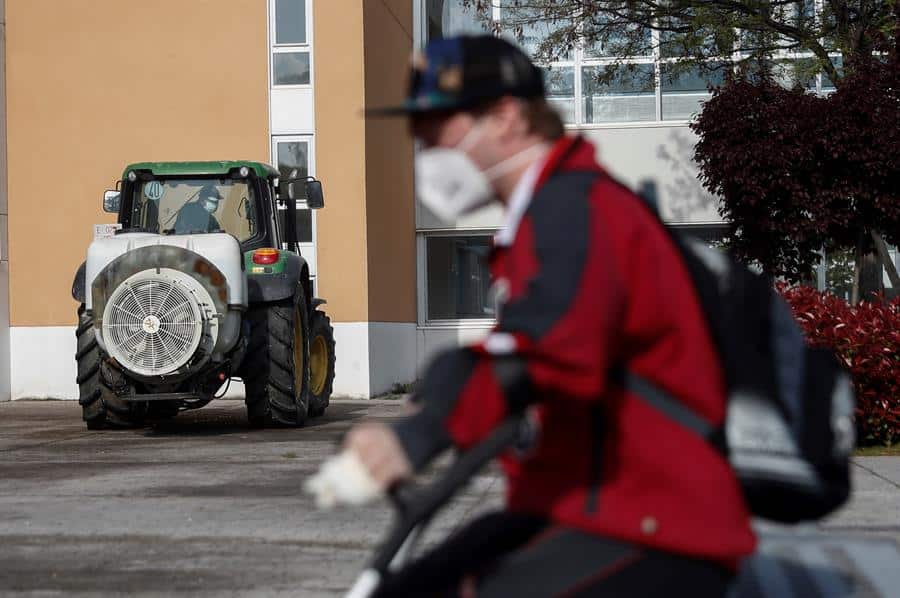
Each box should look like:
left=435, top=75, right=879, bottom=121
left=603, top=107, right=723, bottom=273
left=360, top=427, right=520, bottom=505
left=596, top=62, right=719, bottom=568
left=75, top=304, right=147, bottom=430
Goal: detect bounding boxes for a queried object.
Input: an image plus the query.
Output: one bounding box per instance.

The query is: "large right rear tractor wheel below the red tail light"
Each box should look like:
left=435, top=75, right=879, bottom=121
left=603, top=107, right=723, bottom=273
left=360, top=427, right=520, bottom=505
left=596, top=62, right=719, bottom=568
left=242, top=286, right=309, bottom=427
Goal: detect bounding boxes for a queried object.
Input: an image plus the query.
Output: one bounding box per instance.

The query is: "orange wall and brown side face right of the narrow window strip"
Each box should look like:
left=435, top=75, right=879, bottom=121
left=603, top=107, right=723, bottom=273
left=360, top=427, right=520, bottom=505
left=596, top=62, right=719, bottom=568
left=313, top=0, right=416, bottom=322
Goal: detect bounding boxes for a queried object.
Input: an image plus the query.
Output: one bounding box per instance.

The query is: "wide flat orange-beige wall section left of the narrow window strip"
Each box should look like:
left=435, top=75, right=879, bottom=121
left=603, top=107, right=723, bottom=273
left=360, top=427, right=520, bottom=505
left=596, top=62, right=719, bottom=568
left=6, top=0, right=268, bottom=326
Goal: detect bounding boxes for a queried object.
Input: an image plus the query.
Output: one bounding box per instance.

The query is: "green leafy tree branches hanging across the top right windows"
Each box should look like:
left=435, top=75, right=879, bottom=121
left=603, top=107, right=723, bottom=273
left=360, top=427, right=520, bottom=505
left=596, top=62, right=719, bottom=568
left=462, top=0, right=900, bottom=82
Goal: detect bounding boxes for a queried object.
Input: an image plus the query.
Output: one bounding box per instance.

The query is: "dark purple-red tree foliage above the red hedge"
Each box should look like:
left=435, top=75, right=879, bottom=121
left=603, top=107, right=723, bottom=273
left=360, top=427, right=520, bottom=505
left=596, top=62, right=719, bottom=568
left=691, top=57, right=900, bottom=281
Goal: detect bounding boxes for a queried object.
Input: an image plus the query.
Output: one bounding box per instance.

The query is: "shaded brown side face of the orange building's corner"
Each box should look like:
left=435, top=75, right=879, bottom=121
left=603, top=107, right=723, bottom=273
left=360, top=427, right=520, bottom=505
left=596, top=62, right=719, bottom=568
left=365, top=0, right=416, bottom=322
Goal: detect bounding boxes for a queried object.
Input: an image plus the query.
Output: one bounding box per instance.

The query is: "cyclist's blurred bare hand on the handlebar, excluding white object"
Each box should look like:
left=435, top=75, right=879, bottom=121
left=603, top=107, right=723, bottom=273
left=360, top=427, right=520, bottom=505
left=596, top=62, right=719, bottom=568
left=344, top=423, right=413, bottom=490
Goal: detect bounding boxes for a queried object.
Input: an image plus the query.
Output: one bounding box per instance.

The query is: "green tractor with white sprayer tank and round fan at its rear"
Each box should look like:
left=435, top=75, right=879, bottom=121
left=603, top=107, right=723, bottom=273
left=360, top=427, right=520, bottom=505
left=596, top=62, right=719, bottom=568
left=72, top=162, right=335, bottom=429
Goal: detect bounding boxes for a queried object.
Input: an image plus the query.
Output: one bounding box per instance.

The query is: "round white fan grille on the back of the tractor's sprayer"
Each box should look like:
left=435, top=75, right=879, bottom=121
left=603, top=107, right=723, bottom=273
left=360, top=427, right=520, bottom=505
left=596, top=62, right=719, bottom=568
left=103, top=275, right=203, bottom=376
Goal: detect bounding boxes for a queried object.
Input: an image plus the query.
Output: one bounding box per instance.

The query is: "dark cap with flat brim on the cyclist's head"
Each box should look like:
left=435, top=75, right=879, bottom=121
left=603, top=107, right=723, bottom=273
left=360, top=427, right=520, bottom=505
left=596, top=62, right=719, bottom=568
left=367, top=35, right=544, bottom=116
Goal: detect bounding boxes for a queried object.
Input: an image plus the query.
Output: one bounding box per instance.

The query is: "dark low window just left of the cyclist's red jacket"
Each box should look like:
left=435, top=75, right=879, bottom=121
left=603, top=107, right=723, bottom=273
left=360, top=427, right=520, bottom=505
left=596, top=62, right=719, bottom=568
left=425, top=235, right=495, bottom=320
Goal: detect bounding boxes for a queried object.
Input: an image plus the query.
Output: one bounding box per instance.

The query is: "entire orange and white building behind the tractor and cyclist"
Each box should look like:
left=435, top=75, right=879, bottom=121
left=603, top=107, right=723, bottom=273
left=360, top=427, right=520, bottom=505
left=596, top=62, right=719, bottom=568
left=0, top=0, right=892, bottom=400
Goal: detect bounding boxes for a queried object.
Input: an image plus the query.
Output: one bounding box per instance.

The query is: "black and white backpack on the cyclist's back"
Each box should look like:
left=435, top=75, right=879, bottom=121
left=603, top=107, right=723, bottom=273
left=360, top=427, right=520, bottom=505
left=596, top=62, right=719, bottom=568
left=621, top=179, right=856, bottom=523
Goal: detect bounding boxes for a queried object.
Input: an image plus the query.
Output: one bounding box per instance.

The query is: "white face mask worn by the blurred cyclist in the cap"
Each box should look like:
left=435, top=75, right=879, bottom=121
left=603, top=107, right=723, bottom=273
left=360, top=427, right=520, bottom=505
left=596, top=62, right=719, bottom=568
left=416, top=121, right=540, bottom=221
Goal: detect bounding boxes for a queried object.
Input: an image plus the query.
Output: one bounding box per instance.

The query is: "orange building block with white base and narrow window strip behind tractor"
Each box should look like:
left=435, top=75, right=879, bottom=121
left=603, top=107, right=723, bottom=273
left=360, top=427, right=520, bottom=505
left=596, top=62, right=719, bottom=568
left=0, top=0, right=416, bottom=399
